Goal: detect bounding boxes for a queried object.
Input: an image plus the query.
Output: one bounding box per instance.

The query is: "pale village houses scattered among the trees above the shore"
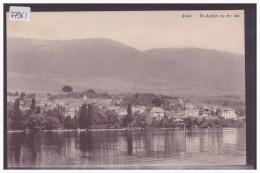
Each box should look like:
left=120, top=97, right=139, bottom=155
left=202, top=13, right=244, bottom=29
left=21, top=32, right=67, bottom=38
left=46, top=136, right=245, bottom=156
left=7, top=94, right=238, bottom=120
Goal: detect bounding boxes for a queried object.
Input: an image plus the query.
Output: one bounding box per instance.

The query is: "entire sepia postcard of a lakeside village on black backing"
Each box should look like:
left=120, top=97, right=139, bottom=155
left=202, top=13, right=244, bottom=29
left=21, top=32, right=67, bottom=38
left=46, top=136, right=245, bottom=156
left=5, top=4, right=255, bottom=169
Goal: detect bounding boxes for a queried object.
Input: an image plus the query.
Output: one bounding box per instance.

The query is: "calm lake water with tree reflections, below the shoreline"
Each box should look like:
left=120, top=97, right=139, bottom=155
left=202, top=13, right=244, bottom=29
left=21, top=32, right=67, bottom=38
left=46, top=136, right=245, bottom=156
left=7, top=128, right=246, bottom=168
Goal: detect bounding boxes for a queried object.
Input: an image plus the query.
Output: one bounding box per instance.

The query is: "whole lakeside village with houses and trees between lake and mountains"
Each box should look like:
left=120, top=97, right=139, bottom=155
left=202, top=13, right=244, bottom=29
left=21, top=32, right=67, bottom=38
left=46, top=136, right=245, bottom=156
left=7, top=86, right=245, bottom=131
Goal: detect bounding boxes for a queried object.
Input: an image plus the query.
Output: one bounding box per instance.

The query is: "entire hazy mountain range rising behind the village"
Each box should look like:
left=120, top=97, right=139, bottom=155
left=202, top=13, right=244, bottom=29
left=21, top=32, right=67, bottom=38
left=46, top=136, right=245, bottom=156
left=7, top=38, right=244, bottom=94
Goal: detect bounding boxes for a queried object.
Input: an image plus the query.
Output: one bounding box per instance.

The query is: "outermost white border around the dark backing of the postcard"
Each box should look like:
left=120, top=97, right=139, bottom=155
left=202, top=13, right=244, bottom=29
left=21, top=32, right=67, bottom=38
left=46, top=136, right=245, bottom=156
left=0, top=0, right=260, bottom=173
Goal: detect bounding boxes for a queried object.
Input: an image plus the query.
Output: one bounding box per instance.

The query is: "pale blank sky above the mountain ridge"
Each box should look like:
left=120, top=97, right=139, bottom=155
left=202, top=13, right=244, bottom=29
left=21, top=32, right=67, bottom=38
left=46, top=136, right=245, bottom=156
left=7, top=10, right=244, bottom=54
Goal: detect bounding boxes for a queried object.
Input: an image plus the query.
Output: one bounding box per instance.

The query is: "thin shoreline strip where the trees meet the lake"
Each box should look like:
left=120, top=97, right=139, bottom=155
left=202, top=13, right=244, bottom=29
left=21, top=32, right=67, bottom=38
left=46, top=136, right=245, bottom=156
left=7, top=127, right=245, bottom=133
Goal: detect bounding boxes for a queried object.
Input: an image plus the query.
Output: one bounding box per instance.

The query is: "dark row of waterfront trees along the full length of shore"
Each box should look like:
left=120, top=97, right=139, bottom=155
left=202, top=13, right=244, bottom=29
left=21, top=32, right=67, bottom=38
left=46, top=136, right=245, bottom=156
left=8, top=98, right=245, bottom=130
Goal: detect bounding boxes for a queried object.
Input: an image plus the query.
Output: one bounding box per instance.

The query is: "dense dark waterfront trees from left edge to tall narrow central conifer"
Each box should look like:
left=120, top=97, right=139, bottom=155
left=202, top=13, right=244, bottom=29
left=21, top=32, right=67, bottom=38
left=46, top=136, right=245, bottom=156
left=7, top=98, right=133, bottom=130
